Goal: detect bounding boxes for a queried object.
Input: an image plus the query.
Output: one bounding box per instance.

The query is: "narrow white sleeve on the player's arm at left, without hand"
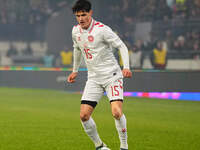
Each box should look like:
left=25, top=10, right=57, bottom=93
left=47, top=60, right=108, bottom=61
left=72, top=32, right=81, bottom=72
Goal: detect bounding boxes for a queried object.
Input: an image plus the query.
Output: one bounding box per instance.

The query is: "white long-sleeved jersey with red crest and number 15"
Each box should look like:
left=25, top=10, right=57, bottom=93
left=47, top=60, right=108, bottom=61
left=72, top=19, right=129, bottom=84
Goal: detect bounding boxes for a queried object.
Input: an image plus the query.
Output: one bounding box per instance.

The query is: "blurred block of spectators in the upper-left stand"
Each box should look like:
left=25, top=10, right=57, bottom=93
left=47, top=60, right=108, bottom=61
left=0, top=0, right=72, bottom=24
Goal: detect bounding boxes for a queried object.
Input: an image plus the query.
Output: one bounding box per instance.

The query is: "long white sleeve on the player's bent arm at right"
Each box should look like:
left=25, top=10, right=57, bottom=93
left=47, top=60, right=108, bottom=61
left=102, top=27, right=130, bottom=69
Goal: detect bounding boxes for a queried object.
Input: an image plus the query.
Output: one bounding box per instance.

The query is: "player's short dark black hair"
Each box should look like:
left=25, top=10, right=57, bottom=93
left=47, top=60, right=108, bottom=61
left=72, top=0, right=92, bottom=13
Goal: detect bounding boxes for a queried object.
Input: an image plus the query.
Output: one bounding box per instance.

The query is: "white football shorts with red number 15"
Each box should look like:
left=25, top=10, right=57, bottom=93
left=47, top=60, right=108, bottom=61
left=81, top=78, right=123, bottom=103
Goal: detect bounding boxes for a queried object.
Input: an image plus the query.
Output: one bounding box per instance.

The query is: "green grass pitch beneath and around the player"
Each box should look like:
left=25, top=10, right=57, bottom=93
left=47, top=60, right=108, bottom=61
left=0, top=88, right=200, bottom=150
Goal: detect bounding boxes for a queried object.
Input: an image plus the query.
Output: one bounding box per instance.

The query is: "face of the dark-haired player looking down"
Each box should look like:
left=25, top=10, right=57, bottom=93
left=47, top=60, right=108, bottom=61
left=75, top=10, right=92, bottom=29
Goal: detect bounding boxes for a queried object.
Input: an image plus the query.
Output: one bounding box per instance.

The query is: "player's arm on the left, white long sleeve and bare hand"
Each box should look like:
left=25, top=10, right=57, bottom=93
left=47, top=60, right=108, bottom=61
left=67, top=27, right=81, bottom=83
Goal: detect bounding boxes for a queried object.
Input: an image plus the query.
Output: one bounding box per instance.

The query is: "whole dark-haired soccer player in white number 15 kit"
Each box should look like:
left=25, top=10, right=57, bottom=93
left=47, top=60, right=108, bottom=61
left=67, top=0, right=132, bottom=150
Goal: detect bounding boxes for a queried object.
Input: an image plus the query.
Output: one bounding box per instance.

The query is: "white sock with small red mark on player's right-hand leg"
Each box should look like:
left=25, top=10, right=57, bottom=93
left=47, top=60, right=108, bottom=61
left=115, top=115, right=128, bottom=149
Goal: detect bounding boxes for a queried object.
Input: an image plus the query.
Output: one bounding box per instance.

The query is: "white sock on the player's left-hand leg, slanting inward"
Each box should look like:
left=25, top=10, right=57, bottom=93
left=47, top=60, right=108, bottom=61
left=81, top=117, right=102, bottom=147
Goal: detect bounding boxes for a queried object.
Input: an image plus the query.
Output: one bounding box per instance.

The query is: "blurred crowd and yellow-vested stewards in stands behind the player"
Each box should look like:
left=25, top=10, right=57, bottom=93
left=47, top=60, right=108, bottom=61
left=0, top=0, right=200, bottom=69
